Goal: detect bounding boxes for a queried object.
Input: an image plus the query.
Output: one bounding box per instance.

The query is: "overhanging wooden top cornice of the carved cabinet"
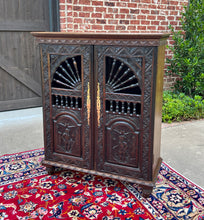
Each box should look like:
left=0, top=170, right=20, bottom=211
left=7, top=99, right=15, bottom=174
left=31, top=32, right=169, bottom=46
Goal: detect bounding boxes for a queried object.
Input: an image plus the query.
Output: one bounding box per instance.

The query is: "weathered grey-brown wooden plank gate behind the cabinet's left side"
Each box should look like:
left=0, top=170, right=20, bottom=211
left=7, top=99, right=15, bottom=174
left=0, top=0, right=58, bottom=111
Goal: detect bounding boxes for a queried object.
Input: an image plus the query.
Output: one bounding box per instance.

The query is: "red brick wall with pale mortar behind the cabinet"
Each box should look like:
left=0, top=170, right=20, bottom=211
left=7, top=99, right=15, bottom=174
left=57, top=0, right=188, bottom=89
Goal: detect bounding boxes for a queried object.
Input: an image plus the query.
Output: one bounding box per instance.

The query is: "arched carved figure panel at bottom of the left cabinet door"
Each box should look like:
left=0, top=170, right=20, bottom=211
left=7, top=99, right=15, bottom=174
left=54, top=115, right=82, bottom=157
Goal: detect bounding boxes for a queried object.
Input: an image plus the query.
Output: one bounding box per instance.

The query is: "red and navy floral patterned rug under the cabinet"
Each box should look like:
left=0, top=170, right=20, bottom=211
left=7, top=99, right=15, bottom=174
left=0, top=149, right=204, bottom=220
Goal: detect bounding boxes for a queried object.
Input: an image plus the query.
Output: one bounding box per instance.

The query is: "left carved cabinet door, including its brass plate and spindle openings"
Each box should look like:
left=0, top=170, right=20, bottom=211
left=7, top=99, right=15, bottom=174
left=41, top=44, right=93, bottom=169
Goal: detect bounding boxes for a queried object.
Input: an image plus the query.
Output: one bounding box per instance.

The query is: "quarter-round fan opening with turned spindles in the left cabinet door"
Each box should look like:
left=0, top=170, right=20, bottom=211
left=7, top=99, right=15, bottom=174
left=52, top=56, right=81, bottom=90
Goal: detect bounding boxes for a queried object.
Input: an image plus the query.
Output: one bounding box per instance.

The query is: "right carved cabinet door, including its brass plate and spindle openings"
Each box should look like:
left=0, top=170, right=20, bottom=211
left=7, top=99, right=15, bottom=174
left=94, top=46, right=155, bottom=180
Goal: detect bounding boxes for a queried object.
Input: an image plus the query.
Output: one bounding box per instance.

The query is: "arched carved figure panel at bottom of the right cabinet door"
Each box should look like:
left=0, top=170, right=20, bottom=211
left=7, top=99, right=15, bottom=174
left=106, top=121, right=139, bottom=168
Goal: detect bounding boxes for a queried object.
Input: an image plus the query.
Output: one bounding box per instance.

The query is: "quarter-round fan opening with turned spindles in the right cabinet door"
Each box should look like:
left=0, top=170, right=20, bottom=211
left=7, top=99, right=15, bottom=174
left=106, top=56, right=141, bottom=95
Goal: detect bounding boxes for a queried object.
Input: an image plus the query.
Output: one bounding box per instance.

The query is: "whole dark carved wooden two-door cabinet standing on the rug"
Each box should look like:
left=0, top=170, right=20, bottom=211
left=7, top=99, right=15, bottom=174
left=33, top=33, right=168, bottom=196
